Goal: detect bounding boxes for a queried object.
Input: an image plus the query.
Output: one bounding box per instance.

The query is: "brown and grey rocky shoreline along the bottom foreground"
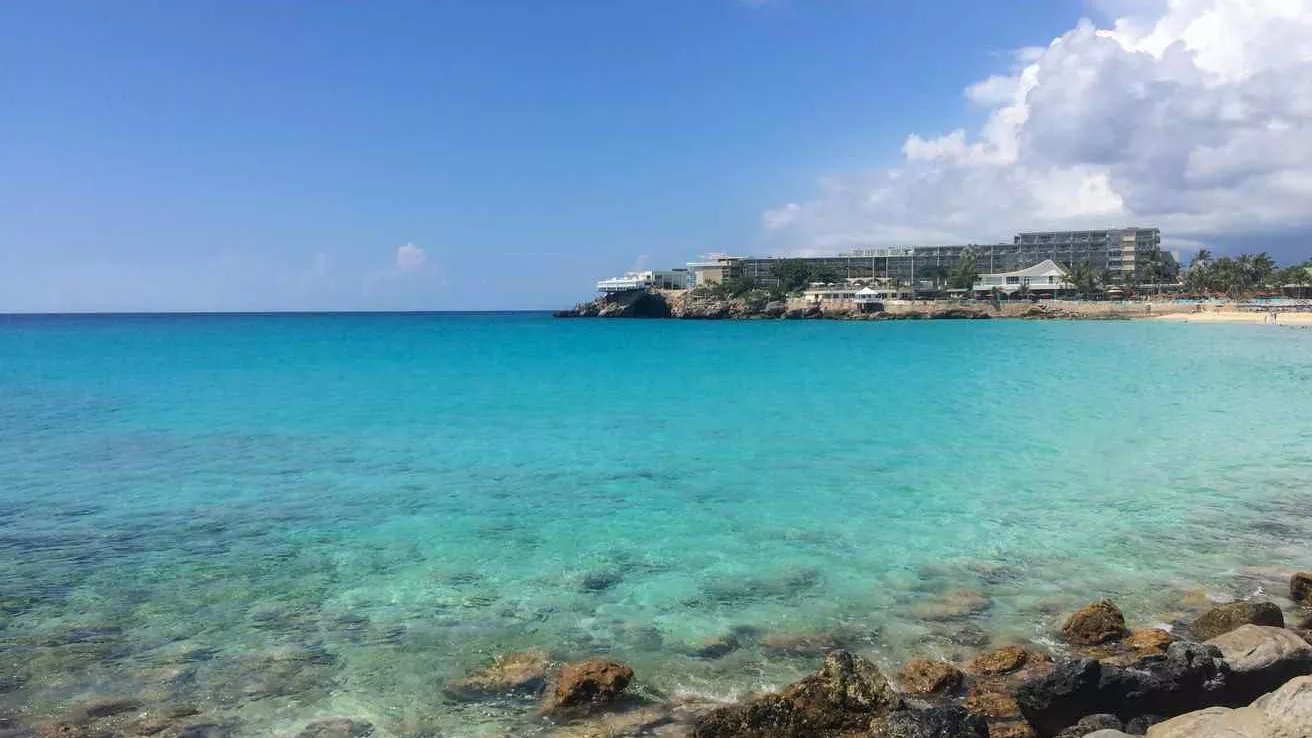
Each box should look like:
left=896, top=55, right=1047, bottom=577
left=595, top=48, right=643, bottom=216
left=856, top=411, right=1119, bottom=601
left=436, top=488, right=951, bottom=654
left=17, top=571, right=1312, bottom=738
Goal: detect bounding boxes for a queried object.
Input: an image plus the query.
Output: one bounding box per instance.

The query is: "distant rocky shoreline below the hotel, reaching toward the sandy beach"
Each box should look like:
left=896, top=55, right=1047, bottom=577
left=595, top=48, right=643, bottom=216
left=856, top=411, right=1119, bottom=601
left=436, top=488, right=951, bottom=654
left=552, top=290, right=1127, bottom=320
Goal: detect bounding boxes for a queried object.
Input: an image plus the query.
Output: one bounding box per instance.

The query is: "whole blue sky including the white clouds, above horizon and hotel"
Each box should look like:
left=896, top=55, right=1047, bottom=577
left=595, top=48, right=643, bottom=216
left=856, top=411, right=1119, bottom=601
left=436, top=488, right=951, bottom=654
left=0, top=0, right=1312, bottom=311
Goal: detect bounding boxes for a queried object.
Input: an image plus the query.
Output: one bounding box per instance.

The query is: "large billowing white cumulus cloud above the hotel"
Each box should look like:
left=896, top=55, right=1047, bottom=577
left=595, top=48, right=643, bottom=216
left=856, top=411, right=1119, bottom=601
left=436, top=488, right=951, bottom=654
left=762, top=0, right=1312, bottom=251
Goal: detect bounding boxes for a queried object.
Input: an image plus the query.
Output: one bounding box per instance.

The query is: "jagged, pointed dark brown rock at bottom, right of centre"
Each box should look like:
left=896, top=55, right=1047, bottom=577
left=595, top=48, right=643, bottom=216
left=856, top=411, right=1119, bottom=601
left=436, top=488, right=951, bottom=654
left=693, top=651, right=903, bottom=738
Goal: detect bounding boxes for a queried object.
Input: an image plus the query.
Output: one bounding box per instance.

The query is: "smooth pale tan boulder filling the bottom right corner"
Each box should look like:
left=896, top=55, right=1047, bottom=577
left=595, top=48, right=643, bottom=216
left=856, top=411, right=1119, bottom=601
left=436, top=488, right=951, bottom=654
left=1148, top=676, right=1312, bottom=738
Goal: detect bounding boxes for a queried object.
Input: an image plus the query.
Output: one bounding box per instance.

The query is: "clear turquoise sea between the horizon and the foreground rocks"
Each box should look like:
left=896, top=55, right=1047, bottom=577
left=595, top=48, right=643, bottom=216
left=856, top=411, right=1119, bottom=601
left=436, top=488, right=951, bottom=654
left=0, top=314, right=1312, bottom=737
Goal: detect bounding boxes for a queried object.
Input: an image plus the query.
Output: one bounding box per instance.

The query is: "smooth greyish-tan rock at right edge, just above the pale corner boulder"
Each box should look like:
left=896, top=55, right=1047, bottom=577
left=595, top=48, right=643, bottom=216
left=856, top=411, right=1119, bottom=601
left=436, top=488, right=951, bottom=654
left=1207, top=625, right=1312, bottom=704
